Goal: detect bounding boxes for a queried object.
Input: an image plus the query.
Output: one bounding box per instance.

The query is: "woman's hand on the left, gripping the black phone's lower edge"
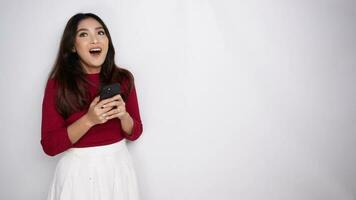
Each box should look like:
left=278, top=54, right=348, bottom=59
left=86, top=96, right=112, bottom=126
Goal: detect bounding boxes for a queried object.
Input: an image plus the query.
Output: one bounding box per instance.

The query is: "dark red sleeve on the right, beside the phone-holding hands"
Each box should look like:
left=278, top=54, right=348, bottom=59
left=125, top=83, right=143, bottom=141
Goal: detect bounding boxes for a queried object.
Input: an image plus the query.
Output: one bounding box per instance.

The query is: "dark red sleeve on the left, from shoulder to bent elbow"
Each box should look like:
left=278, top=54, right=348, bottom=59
left=41, top=80, right=72, bottom=156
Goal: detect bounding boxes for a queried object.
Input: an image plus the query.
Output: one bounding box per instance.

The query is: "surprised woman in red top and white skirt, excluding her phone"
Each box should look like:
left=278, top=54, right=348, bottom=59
left=41, top=13, right=142, bottom=200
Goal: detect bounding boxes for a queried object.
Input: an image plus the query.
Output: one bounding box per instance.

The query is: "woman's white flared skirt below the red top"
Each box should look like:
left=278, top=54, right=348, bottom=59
left=47, top=139, right=139, bottom=200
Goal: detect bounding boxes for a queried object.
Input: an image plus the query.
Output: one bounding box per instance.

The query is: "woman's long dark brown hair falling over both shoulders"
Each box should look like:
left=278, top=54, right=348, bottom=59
left=48, top=13, right=134, bottom=118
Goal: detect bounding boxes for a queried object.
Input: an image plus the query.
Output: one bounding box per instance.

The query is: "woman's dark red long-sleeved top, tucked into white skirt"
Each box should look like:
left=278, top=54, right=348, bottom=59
left=41, top=74, right=143, bottom=156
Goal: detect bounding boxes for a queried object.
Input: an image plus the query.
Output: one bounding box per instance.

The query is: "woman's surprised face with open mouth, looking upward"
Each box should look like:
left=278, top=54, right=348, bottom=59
left=73, top=18, right=109, bottom=74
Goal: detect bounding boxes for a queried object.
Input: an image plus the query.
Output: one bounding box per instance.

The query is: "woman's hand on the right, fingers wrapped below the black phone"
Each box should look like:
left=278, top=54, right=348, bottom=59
left=102, top=94, right=129, bottom=120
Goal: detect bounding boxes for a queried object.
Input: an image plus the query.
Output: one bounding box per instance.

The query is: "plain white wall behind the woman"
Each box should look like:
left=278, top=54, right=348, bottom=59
left=0, top=0, right=356, bottom=200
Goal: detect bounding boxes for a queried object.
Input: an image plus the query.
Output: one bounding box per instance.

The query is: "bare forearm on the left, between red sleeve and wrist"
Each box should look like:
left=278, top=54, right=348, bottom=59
left=67, top=114, right=93, bottom=144
